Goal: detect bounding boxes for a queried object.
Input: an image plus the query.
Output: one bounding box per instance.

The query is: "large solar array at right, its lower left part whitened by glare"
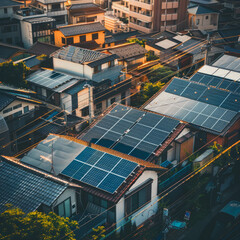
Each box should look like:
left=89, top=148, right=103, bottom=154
left=146, top=78, right=240, bottom=132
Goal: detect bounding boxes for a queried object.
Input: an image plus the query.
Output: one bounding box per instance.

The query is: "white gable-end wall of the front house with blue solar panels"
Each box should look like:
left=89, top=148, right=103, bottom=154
left=116, top=171, right=158, bottom=228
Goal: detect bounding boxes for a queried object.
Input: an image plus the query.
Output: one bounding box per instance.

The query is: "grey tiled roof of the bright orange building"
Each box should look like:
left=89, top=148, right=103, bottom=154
left=58, top=22, right=105, bottom=37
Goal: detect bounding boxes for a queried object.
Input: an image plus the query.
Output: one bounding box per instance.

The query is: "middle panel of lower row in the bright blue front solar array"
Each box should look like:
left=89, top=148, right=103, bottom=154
left=81, top=167, right=108, bottom=186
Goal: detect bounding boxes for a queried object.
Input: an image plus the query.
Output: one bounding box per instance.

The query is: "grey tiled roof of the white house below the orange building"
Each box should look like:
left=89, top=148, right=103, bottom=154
left=52, top=46, right=117, bottom=67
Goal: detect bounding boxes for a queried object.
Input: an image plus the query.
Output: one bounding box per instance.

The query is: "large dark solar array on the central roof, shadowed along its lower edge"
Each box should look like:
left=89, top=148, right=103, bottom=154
left=82, top=105, right=179, bottom=160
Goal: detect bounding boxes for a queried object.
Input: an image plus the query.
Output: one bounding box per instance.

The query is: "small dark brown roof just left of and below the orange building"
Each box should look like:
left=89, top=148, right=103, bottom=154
left=27, top=42, right=60, bottom=56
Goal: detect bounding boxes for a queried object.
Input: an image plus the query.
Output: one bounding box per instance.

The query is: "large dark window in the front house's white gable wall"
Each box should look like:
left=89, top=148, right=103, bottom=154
left=125, top=179, right=152, bottom=215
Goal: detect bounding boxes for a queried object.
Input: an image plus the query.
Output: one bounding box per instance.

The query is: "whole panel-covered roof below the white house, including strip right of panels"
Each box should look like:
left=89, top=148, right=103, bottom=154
left=27, top=69, right=83, bottom=92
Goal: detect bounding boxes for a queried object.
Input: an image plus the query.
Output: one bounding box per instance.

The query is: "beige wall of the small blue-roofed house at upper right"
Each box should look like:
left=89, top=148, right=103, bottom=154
left=188, top=13, right=219, bottom=30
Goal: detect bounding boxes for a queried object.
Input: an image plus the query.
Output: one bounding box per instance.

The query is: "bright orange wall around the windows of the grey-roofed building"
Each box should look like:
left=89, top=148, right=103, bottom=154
left=54, top=30, right=105, bottom=47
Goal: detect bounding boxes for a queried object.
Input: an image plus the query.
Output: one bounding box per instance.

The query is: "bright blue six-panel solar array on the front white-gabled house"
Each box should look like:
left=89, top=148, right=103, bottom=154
left=61, top=147, right=138, bottom=194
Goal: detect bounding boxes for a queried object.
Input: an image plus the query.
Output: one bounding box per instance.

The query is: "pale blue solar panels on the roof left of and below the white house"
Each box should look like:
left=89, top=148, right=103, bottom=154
left=27, top=70, right=73, bottom=89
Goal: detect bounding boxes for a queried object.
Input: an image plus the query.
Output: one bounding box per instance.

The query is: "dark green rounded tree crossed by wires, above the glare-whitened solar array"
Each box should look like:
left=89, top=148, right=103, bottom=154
left=148, top=65, right=174, bottom=83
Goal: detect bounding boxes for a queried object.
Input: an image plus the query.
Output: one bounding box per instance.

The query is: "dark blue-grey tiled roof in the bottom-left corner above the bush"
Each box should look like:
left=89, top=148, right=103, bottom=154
left=0, top=161, right=67, bottom=213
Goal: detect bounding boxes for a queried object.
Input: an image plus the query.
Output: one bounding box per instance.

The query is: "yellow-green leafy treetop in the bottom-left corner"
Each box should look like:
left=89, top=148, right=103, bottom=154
left=0, top=205, right=78, bottom=240
